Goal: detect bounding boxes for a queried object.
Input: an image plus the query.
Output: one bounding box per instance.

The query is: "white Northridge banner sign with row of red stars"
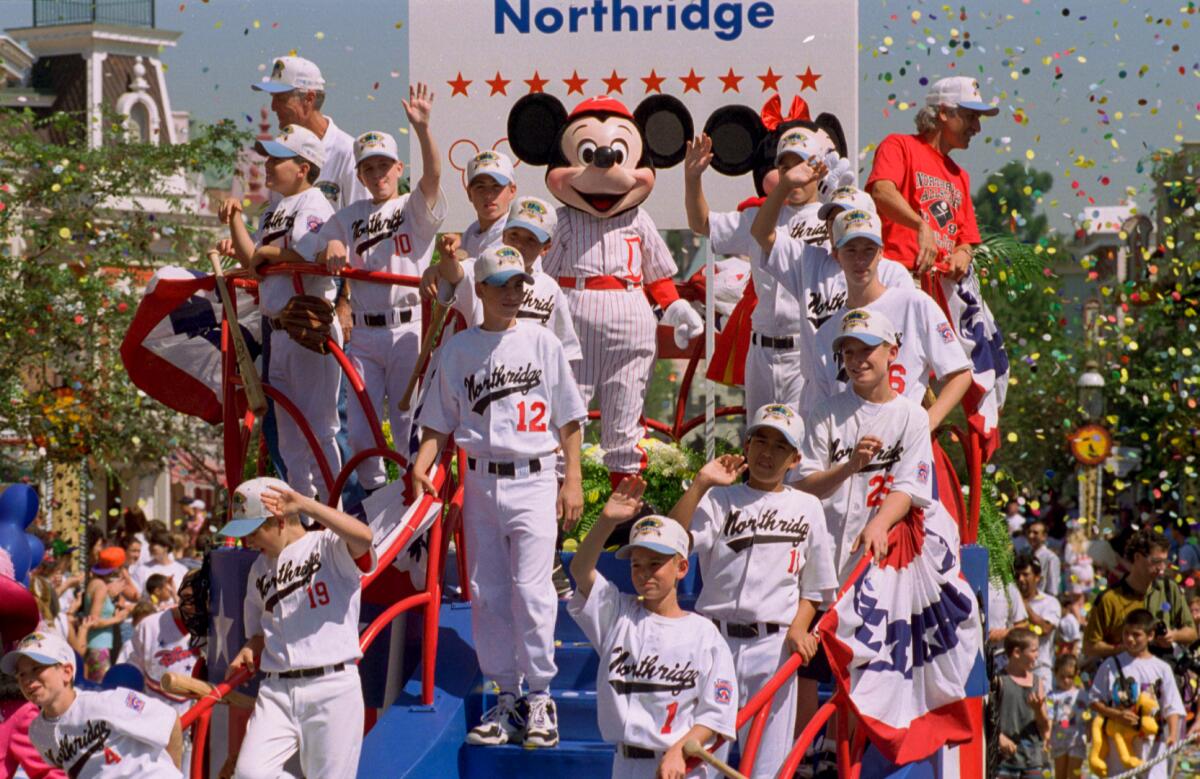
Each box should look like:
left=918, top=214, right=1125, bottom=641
left=408, top=0, right=858, bottom=230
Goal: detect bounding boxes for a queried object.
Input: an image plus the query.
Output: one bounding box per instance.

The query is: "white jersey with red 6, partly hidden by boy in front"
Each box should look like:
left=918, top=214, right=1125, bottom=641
left=804, top=287, right=971, bottom=408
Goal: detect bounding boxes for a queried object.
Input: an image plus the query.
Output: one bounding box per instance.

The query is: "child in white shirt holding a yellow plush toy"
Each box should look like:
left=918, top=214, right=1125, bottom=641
left=1088, top=609, right=1184, bottom=779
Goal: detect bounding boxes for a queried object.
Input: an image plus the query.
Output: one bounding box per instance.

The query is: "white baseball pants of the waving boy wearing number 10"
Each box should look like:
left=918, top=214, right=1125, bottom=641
left=346, top=312, right=421, bottom=490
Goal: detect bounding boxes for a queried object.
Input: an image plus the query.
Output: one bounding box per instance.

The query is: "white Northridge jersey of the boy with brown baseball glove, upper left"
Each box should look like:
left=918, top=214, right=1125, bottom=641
left=254, top=187, right=336, bottom=317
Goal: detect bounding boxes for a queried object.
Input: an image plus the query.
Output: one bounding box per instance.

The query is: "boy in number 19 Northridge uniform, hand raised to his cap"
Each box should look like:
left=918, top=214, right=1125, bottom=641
left=221, top=477, right=376, bottom=779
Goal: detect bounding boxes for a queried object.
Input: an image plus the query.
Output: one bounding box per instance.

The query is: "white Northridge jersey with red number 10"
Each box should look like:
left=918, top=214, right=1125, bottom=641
left=320, top=191, right=446, bottom=313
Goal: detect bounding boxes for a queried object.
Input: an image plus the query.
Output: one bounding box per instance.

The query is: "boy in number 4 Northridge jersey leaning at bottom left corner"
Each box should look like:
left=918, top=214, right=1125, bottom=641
left=0, top=633, right=184, bottom=779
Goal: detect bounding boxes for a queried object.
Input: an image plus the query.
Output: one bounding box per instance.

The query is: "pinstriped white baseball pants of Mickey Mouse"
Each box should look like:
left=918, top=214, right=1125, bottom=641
left=564, top=287, right=658, bottom=473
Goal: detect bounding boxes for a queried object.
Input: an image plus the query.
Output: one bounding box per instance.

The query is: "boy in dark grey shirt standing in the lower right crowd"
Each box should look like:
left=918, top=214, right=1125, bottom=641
left=995, top=628, right=1050, bottom=779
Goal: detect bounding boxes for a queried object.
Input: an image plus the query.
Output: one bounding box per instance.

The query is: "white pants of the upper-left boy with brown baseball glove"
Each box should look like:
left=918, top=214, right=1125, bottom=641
left=266, top=319, right=342, bottom=503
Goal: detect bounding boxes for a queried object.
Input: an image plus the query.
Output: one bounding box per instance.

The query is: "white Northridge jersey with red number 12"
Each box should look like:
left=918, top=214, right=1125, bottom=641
left=419, top=320, right=588, bottom=461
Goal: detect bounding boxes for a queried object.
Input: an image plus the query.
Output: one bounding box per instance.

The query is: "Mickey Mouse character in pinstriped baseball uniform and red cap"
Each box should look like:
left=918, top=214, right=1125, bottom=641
left=508, top=94, right=704, bottom=485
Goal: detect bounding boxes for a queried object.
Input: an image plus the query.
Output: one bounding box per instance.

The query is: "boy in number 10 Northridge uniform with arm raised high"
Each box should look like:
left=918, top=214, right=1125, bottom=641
left=319, top=84, right=446, bottom=493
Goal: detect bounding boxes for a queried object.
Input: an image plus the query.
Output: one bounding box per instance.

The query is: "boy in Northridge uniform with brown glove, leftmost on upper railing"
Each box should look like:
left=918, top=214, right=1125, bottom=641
left=218, top=125, right=342, bottom=501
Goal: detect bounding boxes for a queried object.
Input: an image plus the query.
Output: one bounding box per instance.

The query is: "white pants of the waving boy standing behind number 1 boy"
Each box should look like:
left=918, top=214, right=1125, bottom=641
left=725, top=630, right=796, bottom=779
